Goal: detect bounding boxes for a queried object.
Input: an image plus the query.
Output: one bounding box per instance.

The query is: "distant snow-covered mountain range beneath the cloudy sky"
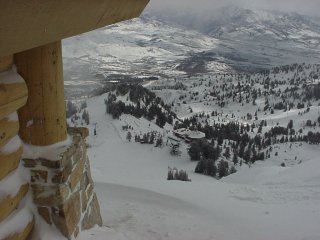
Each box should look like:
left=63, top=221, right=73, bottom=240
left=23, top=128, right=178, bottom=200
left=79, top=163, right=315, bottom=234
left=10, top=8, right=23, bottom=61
left=63, top=7, right=320, bottom=96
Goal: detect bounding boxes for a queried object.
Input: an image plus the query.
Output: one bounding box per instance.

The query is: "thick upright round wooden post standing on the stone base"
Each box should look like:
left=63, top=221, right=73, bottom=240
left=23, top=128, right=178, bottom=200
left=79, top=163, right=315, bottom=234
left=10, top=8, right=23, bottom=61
left=15, top=41, right=67, bottom=146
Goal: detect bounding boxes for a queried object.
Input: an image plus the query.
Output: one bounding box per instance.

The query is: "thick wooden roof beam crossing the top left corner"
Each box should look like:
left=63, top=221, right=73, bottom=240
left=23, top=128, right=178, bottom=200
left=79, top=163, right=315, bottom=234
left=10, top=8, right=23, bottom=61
left=0, top=0, right=149, bottom=57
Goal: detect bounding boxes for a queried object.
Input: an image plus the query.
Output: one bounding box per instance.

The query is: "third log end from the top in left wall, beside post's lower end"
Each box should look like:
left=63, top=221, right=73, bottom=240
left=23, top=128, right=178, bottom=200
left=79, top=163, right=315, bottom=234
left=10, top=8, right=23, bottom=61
left=0, top=118, right=19, bottom=147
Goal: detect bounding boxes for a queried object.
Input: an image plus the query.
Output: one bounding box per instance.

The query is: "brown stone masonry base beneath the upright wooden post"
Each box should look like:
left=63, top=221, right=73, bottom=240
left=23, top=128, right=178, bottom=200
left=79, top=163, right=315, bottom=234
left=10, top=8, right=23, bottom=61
left=23, top=128, right=102, bottom=238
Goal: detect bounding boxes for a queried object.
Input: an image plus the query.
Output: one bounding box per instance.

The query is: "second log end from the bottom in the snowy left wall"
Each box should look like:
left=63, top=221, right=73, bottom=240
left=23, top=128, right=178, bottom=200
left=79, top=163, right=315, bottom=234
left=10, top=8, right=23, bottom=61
left=0, top=183, right=29, bottom=222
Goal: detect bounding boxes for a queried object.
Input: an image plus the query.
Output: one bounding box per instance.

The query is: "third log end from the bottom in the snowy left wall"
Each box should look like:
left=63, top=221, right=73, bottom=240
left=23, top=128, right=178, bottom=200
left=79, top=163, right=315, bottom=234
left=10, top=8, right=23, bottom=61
left=0, top=147, right=23, bottom=181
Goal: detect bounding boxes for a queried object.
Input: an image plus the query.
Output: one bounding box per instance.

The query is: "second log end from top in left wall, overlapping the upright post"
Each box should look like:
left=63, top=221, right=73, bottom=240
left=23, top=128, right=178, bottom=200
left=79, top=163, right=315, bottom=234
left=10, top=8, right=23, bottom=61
left=0, top=82, right=28, bottom=119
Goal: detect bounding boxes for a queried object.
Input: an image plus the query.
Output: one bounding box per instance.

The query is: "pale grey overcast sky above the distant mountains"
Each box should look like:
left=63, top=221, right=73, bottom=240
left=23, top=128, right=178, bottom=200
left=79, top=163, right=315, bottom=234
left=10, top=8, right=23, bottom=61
left=148, top=0, right=320, bottom=17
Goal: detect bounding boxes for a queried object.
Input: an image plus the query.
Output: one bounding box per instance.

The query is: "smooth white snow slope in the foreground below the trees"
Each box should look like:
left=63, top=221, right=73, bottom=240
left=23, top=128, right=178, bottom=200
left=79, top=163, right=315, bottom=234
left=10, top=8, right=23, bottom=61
left=69, top=96, right=320, bottom=240
